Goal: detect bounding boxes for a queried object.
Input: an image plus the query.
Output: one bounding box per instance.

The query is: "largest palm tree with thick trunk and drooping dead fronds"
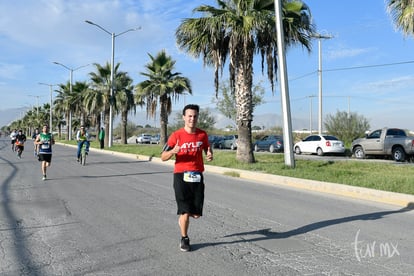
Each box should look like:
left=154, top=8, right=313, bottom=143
left=176, top=0, right=314, bottom=163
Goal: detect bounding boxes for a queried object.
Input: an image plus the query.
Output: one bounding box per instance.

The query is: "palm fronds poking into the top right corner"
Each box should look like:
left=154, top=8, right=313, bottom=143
left=387, top=0, right=414, bottom=36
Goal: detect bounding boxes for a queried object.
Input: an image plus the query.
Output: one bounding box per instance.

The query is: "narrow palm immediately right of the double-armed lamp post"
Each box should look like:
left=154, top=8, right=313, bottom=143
left=115, top=72, right=136, bottom=144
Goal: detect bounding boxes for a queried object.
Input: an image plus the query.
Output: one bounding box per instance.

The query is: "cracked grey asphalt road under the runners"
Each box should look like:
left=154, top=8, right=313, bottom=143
left=0, top=140, right=414, bottom=275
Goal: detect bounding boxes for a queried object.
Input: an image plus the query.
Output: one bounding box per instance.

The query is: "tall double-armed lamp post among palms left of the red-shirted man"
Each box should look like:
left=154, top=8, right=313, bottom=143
left=85, top=20, right=141, bottom=148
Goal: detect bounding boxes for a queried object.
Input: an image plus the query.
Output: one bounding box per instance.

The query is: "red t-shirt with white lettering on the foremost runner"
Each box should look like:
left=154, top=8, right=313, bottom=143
left=167, top=128, right=210, bottom=173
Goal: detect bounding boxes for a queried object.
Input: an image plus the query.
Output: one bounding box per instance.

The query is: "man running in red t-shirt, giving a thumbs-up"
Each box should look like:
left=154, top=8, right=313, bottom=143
left=161, top=104, right=213, bottom=251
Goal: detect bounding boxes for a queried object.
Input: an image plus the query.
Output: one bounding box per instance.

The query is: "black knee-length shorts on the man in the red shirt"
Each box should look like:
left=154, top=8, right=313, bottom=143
left=174, top=173, right=204, bottom=216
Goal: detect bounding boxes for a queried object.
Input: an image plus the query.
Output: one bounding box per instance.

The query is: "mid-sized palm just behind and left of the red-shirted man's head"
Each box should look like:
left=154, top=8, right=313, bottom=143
left=135, top=50, right=192, bottom=143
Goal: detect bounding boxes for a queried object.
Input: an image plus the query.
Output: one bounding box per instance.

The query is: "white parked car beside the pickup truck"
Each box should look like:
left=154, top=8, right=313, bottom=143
left=293, top=135, right=345, bottom=156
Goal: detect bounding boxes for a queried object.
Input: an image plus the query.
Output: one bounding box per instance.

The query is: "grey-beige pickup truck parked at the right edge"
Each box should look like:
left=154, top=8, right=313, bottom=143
left=351, top=128, right=414, bottom=161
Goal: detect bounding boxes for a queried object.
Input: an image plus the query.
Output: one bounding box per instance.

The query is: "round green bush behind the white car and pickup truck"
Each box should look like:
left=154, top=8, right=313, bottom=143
left=324, top=111, right=370, bottom=144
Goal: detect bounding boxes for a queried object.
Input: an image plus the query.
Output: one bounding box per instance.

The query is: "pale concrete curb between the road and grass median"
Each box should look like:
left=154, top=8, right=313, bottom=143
left=61, top=144, right=414, bottom=208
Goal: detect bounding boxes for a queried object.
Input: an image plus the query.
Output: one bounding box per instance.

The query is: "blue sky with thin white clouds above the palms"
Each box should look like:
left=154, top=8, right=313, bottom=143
left=0, top=0, right=414, bottom=130
